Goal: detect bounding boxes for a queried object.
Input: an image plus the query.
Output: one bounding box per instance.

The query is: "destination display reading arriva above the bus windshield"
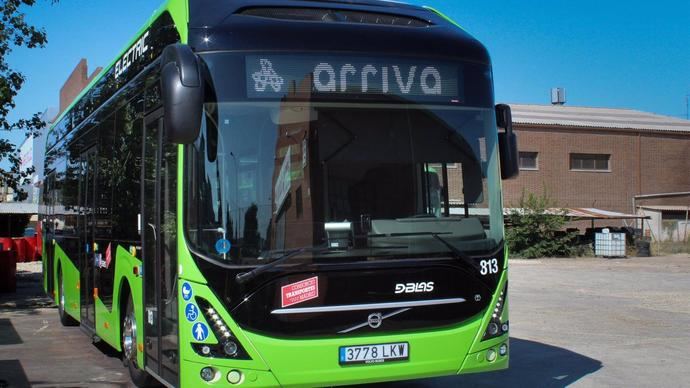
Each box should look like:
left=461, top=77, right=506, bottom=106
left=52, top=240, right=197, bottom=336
left=245, top=55, right=462, bottom=102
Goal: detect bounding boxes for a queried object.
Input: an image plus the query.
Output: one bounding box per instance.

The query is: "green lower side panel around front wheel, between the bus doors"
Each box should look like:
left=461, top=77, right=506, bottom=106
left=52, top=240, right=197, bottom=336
left=95, top=245, right=144, bottom=351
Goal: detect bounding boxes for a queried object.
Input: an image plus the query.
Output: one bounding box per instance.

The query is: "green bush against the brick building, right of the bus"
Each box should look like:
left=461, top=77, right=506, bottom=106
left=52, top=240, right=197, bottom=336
left=506, top=191, right=577, bottom=258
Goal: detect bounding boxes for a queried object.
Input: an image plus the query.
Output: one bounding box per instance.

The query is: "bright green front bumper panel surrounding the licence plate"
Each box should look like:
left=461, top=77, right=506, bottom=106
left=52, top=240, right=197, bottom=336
left=178, top=273, right=509, bottom=387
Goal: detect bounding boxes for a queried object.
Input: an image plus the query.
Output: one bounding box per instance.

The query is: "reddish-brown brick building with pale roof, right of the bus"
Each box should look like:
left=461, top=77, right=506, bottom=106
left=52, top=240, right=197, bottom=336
left=503, top=104, right=690, bottom=230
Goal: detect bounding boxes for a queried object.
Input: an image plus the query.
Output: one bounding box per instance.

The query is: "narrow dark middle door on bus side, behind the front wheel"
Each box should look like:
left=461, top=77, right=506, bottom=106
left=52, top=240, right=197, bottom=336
left=79, top=147, right=98, bottom=330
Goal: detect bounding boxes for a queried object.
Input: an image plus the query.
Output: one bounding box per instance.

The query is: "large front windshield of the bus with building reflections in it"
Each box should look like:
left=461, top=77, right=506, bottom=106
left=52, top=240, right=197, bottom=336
left=184, top=53, right=503, bottom=265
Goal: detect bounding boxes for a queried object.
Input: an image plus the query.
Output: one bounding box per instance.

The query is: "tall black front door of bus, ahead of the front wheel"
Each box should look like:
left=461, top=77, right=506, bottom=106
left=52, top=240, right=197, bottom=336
left=142, top=111, right=179, bottom=386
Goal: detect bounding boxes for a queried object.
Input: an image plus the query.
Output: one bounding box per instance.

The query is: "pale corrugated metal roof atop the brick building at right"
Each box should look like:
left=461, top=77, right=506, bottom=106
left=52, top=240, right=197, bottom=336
left=510, top=104, right=690, bottom=134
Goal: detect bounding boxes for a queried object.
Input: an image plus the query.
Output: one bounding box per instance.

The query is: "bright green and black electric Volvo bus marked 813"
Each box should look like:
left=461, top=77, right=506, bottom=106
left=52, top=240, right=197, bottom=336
left=41, top=0, right=518, bottom=387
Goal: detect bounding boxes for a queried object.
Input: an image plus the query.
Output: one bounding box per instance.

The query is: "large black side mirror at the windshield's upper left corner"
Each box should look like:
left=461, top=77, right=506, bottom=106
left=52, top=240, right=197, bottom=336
left=160, top=44, right=204, bottom=144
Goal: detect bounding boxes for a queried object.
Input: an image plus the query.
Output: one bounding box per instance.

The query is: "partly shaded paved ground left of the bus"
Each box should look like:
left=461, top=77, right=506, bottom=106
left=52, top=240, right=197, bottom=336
left=0, top=262, right=129, bottom=388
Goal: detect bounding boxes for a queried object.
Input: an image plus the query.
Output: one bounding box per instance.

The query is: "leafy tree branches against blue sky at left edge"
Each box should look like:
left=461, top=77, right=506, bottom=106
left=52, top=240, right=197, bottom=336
left=0, top=0, right=57, bottom=199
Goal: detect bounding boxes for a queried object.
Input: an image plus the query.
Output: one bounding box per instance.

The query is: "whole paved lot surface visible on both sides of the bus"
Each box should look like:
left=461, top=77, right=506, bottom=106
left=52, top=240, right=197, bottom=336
left=0, top=255, right=690, bottom=388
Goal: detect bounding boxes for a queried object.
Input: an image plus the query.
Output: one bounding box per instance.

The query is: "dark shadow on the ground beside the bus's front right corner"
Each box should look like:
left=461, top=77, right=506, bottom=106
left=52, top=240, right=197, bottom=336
left=367, top=338, right=603, bottom=388
